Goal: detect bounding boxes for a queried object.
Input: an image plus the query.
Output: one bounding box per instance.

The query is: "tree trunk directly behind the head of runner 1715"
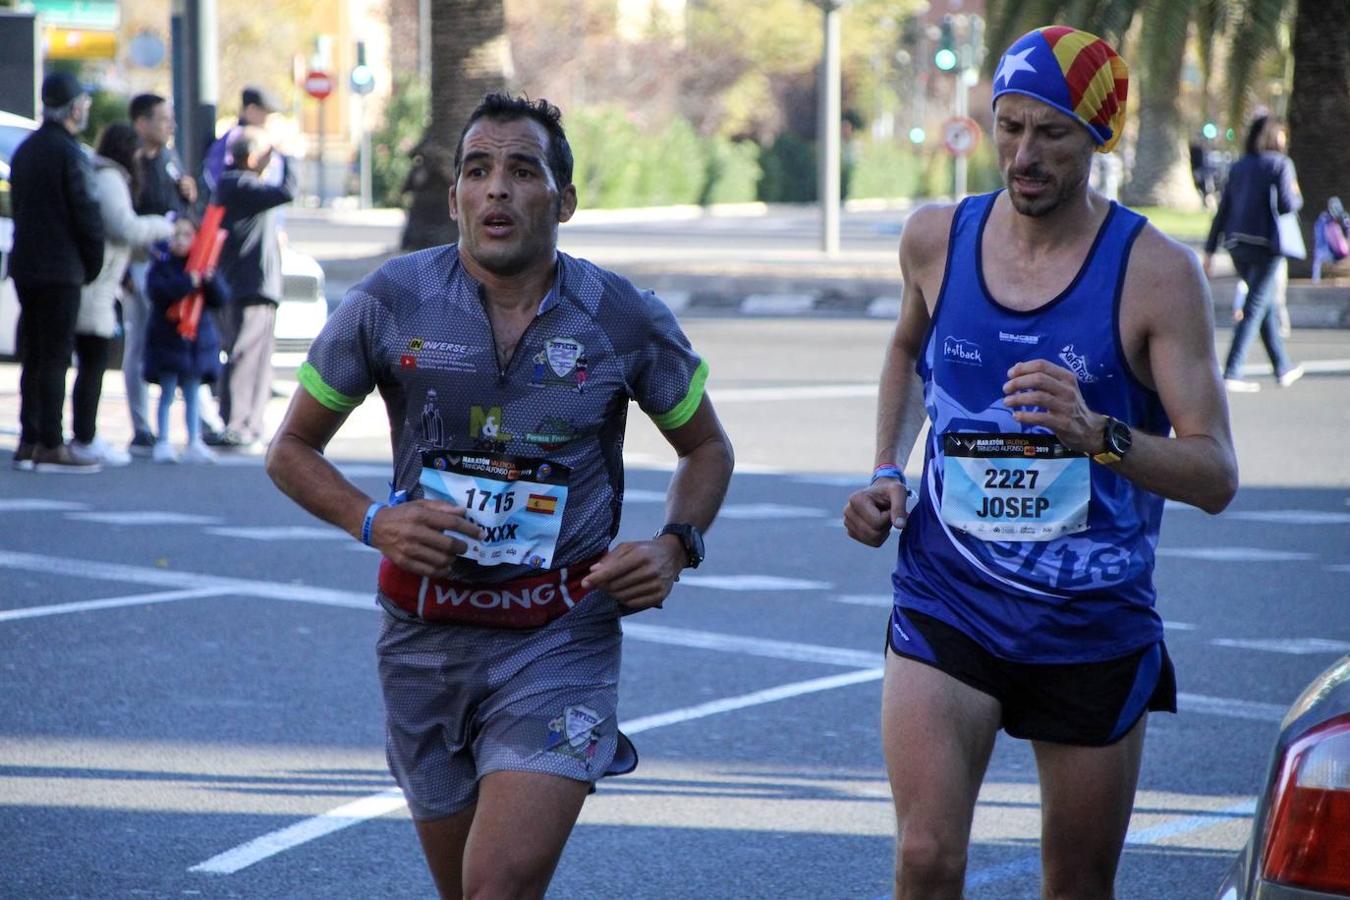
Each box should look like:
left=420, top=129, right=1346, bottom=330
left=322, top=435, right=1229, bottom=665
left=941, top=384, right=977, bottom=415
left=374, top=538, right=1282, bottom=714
left=402, top=0, right=510, bottom=250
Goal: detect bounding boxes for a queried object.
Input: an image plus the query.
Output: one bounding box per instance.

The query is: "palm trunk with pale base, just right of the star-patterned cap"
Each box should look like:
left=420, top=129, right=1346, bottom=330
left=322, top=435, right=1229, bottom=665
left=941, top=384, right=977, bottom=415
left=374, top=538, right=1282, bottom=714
left=1121, top=0, right=1200, bottom=209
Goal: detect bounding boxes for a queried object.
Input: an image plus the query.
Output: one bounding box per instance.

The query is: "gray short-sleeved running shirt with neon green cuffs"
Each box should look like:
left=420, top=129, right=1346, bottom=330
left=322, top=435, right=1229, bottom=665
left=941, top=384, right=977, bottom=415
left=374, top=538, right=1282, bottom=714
left=298, top=246, right=707, bottom=583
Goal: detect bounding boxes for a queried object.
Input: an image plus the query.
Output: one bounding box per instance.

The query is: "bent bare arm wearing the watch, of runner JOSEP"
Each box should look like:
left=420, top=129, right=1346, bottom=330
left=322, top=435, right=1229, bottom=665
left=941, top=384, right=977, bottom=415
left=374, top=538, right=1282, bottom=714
left=1004, top=227, right=1238, bottom=513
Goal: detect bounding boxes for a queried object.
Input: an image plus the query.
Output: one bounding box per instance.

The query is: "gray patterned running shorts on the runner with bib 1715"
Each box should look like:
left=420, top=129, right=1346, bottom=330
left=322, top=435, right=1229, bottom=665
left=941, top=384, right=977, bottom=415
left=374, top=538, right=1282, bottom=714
left=375, top=591, right=636, bottom=819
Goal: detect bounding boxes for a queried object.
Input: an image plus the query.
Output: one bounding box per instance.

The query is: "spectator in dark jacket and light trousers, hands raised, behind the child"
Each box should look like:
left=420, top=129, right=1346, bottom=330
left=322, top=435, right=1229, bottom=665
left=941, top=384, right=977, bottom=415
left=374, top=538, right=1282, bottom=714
left=212, top=127, right=296, bottom=449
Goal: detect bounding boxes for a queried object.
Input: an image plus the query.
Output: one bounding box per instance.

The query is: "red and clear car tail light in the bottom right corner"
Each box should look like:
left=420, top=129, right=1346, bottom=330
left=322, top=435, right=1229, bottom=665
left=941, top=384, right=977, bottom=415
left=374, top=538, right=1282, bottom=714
left=1261, top=715, right=1350, bottom=896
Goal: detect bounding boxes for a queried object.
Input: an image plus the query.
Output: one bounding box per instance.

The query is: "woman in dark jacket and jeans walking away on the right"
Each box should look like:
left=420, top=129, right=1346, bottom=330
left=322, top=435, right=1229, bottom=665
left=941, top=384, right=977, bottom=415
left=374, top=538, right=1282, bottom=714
left=1204, top=116, right=1303, bottom=393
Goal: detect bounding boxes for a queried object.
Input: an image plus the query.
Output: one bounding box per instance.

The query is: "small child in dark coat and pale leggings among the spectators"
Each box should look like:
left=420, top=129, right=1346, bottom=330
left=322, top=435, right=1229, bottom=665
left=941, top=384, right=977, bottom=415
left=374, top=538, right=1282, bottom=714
left=144, top=219, right=230, bottom=463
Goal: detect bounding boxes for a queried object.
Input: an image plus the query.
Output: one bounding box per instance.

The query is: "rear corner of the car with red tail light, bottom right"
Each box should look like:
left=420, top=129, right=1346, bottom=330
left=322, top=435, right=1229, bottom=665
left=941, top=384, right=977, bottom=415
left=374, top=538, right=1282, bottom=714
left=1218, top=656, right=1350, bottom=900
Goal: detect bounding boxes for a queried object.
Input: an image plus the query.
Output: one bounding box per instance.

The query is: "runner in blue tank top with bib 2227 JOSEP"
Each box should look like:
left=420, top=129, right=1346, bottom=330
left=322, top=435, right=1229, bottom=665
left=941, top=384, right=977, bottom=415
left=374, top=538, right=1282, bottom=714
left=845, top=27, right=1238, bottom=897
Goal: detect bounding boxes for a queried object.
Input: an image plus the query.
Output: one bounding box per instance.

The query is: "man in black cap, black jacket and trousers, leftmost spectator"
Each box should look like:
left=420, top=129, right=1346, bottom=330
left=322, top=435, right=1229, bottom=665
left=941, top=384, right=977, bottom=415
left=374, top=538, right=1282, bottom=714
left=9, top=72, right=104, bottom=472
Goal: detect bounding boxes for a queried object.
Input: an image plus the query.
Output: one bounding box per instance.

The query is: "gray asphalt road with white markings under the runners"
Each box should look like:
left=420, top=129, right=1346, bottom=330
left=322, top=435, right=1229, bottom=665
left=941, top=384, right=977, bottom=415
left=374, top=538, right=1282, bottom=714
left=0, top=318, right=1350, bottom=900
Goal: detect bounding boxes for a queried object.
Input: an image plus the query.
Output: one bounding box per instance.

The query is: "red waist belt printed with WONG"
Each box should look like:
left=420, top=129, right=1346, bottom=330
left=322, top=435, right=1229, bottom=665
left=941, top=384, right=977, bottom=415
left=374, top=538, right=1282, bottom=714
left=379, top=553, right=603, bottom=629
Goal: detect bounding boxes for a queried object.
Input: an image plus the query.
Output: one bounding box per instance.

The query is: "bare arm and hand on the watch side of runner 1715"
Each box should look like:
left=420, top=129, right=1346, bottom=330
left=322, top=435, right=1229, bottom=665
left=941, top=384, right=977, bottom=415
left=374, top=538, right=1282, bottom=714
left=582, top=394, right=736, bottom=611
